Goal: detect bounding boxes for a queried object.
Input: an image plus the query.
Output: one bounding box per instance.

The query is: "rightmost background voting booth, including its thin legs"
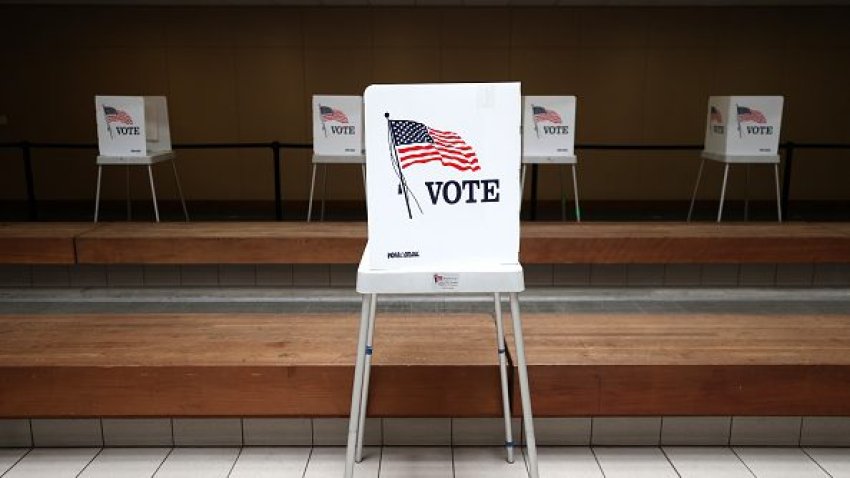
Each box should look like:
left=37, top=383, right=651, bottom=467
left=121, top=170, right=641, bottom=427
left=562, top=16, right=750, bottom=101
left=688, top=96, right=783, bottom=222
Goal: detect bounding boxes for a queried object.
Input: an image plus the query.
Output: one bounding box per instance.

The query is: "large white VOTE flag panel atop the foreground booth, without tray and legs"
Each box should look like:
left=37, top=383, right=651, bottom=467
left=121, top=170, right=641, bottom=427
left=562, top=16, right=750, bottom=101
left=365, top=83, right=521, bottom=268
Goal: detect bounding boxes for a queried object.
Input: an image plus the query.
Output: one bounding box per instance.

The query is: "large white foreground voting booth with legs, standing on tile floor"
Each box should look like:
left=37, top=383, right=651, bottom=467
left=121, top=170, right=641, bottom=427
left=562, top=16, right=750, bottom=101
left=345, top=83, right=538, bottom=478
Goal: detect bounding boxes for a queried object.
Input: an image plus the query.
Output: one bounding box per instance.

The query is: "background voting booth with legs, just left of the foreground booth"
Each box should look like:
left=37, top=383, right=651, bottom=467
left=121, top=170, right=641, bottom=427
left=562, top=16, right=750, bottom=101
left=307, top=95, right=366, bottom=222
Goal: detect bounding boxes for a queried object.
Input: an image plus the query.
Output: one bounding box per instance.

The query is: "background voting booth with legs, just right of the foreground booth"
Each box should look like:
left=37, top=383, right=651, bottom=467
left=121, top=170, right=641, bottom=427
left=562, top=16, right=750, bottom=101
left=522, top=96, right=581, bottom=221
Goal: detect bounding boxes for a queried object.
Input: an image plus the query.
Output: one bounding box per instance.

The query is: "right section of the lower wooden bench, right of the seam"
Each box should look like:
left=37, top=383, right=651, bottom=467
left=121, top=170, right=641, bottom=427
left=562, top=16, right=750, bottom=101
left=511, top=314, right=850, bottom=416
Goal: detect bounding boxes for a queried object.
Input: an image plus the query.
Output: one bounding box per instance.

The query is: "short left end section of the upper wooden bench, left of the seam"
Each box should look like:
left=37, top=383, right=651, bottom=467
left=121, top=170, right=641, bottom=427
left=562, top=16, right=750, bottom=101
left=0, top=222, right=95, bottom=264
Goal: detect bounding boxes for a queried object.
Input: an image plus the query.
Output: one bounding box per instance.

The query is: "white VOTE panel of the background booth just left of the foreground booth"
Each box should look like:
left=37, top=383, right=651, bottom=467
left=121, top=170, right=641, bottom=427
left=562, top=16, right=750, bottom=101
left=313, top=95, right=363, bottom=156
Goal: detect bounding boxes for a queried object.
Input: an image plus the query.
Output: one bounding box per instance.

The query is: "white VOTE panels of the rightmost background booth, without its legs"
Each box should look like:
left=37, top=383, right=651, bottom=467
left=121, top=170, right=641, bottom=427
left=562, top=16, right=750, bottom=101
left=705, top=96, right=783, bottom=156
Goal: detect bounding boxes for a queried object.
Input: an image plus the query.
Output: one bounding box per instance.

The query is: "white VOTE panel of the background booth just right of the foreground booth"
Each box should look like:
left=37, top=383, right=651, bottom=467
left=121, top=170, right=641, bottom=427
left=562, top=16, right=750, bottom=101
left=522, top=96, right=576, bottom=157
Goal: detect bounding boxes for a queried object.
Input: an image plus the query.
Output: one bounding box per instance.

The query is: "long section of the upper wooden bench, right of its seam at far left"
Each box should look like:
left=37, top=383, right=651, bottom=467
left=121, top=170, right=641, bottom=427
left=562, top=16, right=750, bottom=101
left=68, top=222, right=850, bottom=264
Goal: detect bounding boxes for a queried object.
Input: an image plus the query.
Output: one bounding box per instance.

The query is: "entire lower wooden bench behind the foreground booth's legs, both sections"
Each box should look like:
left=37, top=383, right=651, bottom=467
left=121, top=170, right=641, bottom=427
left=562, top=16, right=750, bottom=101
left=0, top=314, right=850, bottom=417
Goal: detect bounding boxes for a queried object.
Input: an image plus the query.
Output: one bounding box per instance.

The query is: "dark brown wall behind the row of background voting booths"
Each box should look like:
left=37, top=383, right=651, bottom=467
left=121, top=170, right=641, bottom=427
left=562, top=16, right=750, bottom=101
left=0, top=7, right=850, bottom=204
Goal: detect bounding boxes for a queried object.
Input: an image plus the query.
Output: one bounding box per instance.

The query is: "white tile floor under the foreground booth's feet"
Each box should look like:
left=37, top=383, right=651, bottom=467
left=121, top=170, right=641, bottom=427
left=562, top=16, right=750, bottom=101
left=0, top=446, right=850, bottom=478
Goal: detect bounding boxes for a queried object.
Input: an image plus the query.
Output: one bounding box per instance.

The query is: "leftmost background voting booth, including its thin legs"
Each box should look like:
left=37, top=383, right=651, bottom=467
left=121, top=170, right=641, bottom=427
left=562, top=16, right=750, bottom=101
left=94, top=96, right=189, bottom=222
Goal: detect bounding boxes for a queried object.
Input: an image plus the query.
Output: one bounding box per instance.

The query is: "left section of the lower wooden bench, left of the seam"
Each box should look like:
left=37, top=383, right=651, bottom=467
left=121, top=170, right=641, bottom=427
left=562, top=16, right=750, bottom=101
left=0, top=314, right=501, bottom=417
